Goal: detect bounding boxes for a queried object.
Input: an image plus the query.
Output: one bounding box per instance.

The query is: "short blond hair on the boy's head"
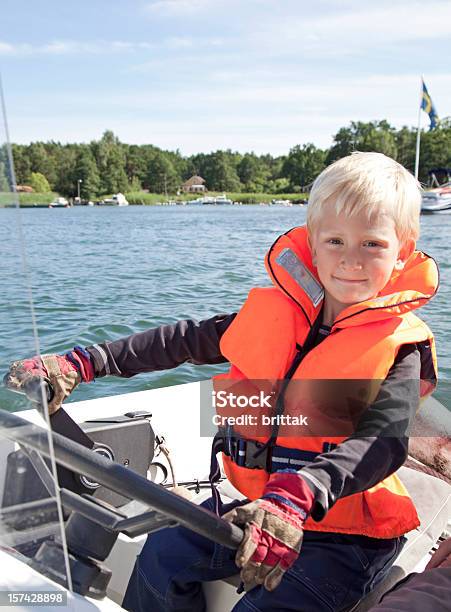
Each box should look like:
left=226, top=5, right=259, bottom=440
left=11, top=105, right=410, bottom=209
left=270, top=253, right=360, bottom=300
left=307, top=151, right=421, bottom=243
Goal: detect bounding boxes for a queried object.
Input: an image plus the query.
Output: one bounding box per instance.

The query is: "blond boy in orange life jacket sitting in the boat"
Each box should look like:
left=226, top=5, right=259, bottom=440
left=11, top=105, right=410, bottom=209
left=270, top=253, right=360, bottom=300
left=7, top=153, right=438, bottom=612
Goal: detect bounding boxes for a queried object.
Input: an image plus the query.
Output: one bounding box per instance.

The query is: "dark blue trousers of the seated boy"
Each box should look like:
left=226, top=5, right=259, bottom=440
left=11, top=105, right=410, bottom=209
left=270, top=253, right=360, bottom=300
left=122, top=498, right=404, bottom=612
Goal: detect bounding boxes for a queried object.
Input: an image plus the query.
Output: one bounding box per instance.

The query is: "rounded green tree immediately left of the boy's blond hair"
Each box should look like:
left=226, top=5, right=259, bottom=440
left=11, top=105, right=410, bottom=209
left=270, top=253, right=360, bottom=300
left=282, top=143, right=326, bottom=191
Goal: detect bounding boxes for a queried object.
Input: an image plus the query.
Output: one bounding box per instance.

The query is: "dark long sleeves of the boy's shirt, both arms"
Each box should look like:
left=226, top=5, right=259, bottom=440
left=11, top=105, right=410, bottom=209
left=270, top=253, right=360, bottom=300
left=87, top=313, right=420, bottom=520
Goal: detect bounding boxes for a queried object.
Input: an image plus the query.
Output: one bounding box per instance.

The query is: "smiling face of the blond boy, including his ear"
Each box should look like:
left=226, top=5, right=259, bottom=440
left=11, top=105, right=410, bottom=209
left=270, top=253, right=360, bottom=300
left=310, top=207, right=415, bottom=321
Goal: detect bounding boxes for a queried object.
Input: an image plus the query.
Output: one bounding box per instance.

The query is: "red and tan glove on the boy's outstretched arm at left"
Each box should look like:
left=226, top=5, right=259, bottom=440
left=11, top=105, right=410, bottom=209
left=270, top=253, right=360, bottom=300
left=3, top=346, right=94, bottom=414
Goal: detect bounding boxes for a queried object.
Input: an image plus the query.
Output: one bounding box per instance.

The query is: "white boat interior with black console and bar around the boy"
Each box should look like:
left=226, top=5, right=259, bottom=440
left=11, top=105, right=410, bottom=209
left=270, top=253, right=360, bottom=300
left=0, top=383, right=451, bottom=612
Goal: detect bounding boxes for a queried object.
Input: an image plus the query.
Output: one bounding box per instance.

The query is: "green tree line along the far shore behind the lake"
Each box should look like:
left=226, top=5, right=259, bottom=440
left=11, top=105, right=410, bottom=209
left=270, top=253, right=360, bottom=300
left=7, top=120, right=451, bottom=199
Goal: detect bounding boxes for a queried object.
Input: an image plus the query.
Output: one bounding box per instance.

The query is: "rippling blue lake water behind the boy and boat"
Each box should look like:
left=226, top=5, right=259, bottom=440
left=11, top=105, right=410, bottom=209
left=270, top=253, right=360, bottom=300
left=0, top=206, right=451, bottom=410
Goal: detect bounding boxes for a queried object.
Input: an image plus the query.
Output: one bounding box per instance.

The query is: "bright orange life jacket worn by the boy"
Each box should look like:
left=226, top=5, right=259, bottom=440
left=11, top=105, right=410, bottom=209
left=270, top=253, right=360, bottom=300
left=217, top=227, right=438, bottom=538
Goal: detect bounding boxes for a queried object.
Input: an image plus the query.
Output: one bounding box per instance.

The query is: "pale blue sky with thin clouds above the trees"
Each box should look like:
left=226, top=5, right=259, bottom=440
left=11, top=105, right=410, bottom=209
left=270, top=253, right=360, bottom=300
left=0, top=0, right=451, bottom=155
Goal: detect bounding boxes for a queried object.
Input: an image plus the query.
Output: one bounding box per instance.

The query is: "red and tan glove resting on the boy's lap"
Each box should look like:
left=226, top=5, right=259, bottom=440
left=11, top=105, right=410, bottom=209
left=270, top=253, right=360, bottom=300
left=223, top=470, right=314, bottom=591
